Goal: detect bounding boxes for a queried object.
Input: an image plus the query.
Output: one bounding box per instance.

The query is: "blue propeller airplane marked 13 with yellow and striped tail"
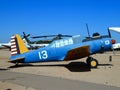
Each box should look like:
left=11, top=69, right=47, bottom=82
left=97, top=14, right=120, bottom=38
left=9, top=30, right=113, bottom=68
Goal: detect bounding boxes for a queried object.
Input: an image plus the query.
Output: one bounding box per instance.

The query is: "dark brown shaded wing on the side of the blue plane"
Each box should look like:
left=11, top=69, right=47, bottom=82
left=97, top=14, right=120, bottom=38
left=64, top=46, right=90, bottom=61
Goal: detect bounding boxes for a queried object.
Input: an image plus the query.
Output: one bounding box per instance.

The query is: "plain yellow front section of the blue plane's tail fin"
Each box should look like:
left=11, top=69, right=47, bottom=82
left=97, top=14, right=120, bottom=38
left=15, top=34, right=28, bottom=54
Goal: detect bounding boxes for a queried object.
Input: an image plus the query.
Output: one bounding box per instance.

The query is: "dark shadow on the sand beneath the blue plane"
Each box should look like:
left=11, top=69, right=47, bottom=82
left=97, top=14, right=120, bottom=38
left=8, top=62, right=113, bottom=72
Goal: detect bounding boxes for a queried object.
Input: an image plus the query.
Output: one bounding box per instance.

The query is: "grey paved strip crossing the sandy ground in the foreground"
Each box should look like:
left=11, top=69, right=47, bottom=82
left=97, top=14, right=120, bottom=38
left=0, top=70, right=120, bottom=90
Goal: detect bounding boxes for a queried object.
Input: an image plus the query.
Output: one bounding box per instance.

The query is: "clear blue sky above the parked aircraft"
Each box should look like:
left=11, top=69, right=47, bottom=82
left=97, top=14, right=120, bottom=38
left=0, top=0, right=120, bottom=42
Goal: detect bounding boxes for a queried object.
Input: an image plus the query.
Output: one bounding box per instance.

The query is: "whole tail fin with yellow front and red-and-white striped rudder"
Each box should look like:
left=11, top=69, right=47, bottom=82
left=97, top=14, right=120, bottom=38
left=11, top=34, right=28, bottom=56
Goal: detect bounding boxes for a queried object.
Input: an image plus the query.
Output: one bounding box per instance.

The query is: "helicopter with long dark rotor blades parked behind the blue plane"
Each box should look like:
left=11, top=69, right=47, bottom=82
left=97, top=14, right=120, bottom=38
left=23, top=32, right=72, bottom=49
